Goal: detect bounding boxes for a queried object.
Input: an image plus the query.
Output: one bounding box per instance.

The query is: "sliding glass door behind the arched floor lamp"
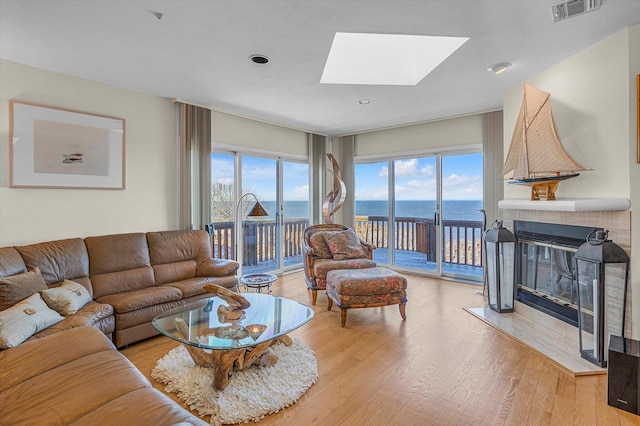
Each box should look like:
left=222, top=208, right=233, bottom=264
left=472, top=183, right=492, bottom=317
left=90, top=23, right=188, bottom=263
left=211, top=152, right=309, bottom=274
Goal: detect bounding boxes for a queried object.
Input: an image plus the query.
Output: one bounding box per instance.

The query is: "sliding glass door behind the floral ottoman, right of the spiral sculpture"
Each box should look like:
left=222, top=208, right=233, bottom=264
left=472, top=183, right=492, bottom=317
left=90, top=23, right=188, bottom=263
left=355, top=153, right=483, bottom=281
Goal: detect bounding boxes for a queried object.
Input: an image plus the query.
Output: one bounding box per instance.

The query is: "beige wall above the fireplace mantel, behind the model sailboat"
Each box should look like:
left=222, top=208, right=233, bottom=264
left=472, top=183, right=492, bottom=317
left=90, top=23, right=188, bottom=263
left=504, top=25, right=640, bottom=339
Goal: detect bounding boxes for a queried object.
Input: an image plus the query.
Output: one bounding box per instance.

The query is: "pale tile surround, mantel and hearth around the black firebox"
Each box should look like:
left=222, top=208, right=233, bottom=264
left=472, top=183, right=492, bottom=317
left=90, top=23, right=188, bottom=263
left=471, top=199, right=632, bottom=375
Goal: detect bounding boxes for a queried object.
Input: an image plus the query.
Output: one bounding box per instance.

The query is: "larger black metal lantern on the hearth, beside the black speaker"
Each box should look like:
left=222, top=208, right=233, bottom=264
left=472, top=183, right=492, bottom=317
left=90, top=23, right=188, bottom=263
left=575, top=229, right=629, bottom=367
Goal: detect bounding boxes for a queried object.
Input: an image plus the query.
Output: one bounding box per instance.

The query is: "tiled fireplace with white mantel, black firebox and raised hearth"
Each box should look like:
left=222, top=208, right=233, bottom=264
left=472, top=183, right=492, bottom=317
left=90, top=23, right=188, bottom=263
left=466, top=199, right=631, bottom=376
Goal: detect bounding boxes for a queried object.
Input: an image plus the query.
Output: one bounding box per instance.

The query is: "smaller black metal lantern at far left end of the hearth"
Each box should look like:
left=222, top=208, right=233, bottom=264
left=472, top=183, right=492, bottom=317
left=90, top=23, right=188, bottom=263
left=484, top=220, right=516, bottom=313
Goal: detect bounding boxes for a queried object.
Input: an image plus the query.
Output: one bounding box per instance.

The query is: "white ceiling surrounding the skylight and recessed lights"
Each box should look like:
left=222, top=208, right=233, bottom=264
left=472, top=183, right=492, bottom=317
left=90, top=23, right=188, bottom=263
left=0, top=0, right=640, bottom=136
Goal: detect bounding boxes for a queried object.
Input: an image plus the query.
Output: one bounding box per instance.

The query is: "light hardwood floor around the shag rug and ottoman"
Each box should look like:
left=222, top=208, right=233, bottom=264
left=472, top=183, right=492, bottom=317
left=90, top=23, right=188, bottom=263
left=122, top=273, right=640, bottom=426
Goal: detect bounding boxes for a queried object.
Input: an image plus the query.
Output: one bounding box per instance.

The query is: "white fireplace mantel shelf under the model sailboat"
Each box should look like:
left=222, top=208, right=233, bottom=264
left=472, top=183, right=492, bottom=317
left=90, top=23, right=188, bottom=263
left=498, top=198, right=631, bottom=212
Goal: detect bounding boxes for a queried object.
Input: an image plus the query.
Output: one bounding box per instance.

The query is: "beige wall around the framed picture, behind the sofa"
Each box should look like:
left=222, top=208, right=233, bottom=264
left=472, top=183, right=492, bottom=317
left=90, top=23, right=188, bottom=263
left=0, top=60, right=178, bottom=246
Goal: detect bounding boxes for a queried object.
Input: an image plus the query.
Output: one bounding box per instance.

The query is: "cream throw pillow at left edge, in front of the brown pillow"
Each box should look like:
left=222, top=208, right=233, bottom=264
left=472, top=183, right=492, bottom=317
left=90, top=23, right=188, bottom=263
left=0, top=293, right=64, bottom=349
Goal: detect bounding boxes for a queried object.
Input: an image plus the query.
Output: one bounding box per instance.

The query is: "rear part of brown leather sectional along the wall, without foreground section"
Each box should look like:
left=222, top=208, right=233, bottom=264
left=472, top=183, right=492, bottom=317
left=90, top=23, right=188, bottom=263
left=0, top=230, right=238, bottom=348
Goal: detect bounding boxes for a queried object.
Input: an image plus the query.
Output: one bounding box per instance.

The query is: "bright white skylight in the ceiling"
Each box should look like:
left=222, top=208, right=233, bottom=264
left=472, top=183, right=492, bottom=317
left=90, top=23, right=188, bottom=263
left=320, top=32, right=469, bottom=86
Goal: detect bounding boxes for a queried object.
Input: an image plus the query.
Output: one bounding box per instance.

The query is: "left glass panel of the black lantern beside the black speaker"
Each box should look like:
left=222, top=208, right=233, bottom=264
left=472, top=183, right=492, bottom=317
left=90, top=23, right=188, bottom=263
left=576, top=259, right=601, bottom=359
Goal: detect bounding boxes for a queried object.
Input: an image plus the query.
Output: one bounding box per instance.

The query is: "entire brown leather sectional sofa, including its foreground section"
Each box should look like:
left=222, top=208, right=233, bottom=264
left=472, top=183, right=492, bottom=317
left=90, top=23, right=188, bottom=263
left=0, top=231, right=238, bottom=425
